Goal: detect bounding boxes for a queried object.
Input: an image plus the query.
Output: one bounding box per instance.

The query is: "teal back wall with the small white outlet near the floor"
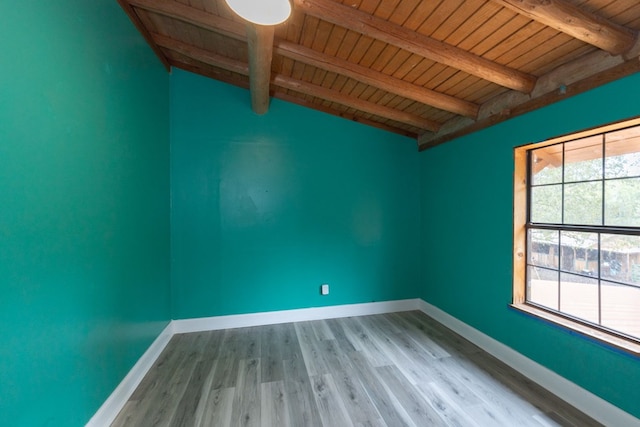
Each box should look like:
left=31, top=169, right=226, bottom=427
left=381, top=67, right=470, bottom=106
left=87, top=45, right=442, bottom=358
left=171, top=71, right=419, bottom=319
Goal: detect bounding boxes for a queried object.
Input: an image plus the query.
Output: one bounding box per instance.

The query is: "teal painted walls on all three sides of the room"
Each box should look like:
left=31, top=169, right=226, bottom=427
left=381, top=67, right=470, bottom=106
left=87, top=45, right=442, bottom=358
left=0, top=0, right=640, bottom=420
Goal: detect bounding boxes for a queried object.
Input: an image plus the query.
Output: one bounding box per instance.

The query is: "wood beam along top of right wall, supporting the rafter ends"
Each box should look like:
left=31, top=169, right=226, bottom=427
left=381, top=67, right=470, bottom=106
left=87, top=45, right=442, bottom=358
left=418, top=50, right=640, bottom=151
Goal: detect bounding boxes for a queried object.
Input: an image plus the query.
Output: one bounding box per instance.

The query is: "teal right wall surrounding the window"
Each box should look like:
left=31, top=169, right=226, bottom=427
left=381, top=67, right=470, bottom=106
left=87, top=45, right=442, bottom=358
left=420, top=74, right=640, bottom=417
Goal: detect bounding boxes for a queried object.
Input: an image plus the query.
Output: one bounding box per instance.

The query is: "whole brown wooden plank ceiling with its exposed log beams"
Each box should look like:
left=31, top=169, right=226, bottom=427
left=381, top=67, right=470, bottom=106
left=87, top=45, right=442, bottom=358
left=118, top=0, right=640, bottom=150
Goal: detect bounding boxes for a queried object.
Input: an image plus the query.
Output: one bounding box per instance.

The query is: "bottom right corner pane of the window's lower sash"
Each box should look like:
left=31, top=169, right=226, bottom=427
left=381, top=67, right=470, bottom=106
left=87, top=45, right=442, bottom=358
left=601, top=282, right=640, bottom=338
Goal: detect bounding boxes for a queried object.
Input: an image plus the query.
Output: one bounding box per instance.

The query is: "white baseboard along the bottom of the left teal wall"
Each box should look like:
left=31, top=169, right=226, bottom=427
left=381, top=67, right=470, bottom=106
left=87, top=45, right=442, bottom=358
left=86, top=322, right=174, bottom=427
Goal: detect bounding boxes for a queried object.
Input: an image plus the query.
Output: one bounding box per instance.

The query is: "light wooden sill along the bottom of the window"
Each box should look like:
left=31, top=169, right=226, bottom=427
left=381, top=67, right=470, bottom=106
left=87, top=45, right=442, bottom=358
left=510, top=303, right=640, bottom=357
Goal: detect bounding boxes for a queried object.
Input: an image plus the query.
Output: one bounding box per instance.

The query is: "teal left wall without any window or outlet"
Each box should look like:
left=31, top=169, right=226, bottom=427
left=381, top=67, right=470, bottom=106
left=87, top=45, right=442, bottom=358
left=0, top=0, right=170, bottom=426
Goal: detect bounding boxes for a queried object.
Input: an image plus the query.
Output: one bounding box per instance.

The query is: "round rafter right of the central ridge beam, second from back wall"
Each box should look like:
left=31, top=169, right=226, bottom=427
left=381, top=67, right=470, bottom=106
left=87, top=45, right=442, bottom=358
left=275, top=40, right=480, bottom=118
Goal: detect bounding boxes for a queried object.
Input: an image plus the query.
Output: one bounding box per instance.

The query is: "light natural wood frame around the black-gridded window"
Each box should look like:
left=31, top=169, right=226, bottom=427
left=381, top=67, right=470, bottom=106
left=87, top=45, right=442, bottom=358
left=511, top=117, right=640, bottom=356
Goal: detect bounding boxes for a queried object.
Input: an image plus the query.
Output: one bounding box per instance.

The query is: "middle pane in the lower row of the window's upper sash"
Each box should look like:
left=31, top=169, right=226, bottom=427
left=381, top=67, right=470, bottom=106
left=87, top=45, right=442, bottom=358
left=564, top=182, right=602, bottom=225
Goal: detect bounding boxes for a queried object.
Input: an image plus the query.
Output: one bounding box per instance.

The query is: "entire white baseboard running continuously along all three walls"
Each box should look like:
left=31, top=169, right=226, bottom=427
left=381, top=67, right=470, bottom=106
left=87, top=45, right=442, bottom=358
left=86, top=298, right=640, bottom=427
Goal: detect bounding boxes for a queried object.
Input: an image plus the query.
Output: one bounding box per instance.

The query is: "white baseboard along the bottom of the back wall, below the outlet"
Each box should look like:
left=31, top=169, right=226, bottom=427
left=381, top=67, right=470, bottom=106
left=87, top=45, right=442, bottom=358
left=172, top=298, right=422, bottom=334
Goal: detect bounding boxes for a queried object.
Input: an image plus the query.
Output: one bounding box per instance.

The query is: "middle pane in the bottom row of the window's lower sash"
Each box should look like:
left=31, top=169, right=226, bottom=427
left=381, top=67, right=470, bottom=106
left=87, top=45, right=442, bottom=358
left=560, top=273, right=598, bottom=323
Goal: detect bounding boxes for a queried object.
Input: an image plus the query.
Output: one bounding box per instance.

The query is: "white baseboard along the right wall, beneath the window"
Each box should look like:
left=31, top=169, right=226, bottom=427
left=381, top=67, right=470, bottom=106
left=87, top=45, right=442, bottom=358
left=419, top=300, right=640, bottom=427
